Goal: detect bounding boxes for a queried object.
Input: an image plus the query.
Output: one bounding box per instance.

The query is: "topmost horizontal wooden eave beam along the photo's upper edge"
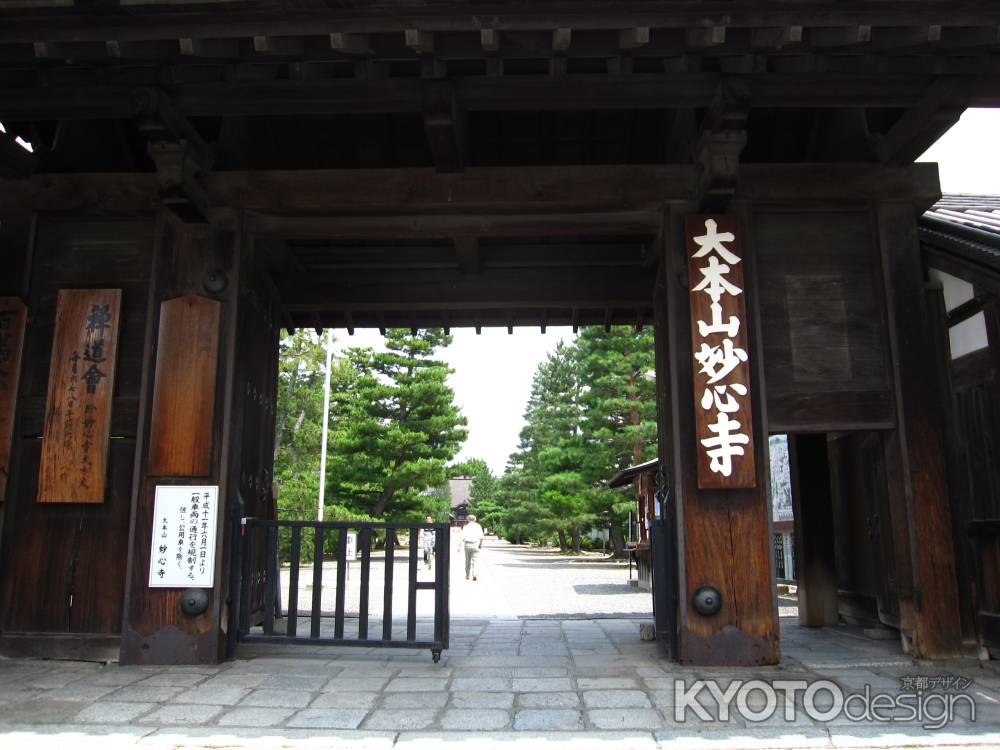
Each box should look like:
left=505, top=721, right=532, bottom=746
left=0, top=5, right=1000, bottom=43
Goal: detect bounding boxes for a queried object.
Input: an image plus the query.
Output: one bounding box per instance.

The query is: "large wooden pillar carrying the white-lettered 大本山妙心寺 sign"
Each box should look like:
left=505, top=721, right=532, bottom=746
left=654, top=204, right=779, bottom=666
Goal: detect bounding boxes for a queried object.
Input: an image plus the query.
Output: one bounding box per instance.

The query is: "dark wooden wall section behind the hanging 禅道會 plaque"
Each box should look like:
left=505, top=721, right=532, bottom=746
left=0, top=216, right=152, bottom=634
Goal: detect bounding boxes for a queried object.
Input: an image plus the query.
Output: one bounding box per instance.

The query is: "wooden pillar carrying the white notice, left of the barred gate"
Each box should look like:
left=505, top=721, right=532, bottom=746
left=121, top=211, right=245, bottom=664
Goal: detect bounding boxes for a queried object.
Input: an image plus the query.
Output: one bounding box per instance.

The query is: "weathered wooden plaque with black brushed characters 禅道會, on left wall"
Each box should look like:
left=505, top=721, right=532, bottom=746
left=38, top=289, right=122, bottom=503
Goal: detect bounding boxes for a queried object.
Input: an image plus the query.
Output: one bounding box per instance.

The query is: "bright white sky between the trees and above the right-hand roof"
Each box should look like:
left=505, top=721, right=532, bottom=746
left=336, top=110, right=1000, bottom=473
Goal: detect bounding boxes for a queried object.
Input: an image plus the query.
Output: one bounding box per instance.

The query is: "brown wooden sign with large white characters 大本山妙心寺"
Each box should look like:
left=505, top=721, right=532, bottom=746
left=684, top=216, right=756, bottom=489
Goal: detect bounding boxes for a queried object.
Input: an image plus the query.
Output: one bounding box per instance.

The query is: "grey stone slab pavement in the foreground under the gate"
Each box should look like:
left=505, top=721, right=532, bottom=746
left=0, top=618, right=1000, bottom=750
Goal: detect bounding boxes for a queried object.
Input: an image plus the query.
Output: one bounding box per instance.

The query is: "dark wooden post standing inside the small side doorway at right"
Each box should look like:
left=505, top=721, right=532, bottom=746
left=788, top=434, right=837, bottom=628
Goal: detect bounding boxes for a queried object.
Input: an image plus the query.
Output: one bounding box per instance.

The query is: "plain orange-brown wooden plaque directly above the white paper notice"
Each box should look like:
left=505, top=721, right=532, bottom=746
left=149, top=295, right=220, bottom=477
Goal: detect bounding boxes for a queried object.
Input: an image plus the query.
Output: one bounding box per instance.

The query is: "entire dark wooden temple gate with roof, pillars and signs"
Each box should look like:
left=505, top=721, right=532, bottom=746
left=0, top=0, right=1000, bottom=665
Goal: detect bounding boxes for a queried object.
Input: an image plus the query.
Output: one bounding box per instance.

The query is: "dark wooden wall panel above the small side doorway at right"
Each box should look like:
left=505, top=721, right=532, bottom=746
left=754, top=211, right=895, bottom=432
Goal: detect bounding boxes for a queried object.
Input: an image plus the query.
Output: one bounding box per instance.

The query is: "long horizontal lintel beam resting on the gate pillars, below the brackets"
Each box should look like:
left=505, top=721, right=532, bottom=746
left=0, top=163, right=940, bottom=214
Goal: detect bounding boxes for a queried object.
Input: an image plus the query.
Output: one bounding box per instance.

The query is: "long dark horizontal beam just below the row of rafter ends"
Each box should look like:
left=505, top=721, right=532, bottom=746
left=0, top=73, right=1000, bottom=120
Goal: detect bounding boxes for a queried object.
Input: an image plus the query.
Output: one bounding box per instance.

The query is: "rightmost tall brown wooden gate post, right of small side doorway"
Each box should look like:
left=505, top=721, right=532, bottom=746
left=877, top=202, right=962, bottom=658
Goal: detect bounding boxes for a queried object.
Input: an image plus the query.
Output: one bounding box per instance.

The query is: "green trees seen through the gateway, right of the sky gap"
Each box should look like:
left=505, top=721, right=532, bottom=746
left=496, top=327, right=656, bottom=554
